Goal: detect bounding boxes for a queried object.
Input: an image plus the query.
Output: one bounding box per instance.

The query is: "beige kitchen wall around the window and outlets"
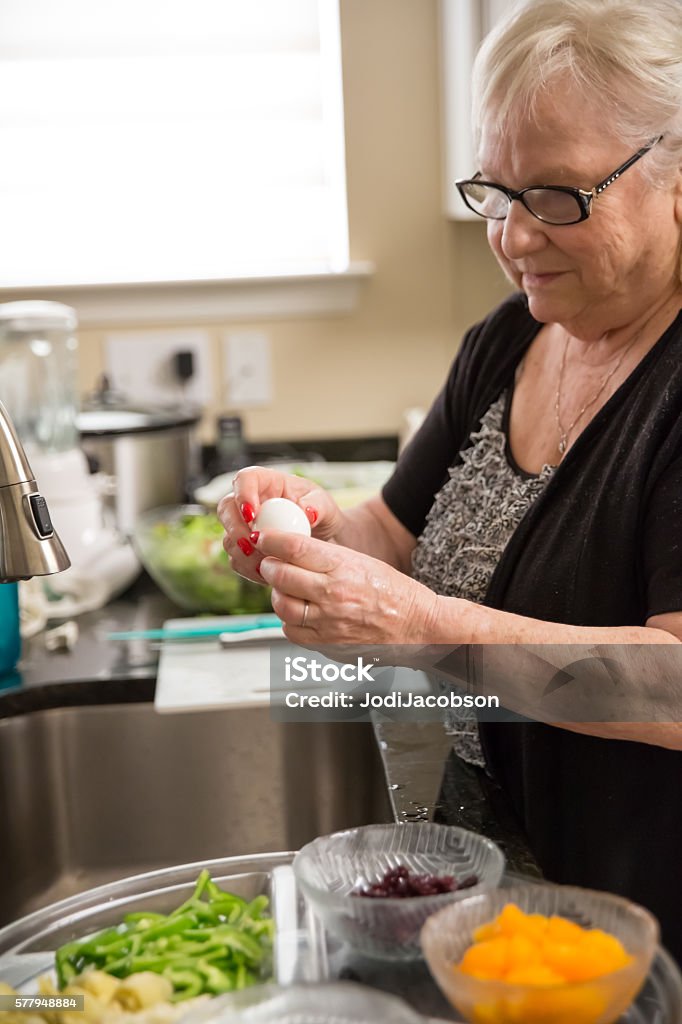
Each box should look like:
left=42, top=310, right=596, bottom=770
left=75, top=0, right=508, bottom=440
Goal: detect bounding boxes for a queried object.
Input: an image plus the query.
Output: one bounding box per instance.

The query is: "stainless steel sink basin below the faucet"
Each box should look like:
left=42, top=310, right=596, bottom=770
left=0, top=703, right=391, bottom=924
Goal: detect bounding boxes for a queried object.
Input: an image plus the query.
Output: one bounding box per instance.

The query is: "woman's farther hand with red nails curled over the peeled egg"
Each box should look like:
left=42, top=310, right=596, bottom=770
left=218, top=466, right=343, bottom=583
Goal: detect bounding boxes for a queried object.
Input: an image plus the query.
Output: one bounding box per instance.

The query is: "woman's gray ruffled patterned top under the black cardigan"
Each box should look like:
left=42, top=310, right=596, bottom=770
left=412, top=393, right=554, bottom=765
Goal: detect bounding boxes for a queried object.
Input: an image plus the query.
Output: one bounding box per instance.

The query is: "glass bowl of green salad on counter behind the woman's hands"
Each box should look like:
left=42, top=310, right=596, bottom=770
left=133, top=505, right=270, bottom=615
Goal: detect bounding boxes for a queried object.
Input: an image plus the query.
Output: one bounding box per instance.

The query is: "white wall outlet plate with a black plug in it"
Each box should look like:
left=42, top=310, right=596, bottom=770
left=104, top=330, right=213, bottom=406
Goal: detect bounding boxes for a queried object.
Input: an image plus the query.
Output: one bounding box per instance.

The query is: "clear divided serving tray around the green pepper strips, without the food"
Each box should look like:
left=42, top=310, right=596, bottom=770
left=0, top=853, right=682, bottom=1024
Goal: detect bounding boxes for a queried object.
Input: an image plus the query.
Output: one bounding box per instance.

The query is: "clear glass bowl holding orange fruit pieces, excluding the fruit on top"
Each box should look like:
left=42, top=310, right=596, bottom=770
left=422, top=885, right=658, bottom=1024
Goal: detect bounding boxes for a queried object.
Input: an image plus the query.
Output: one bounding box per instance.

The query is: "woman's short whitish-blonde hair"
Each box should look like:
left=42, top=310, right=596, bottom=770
left=473, top=0, right=682, bottom=184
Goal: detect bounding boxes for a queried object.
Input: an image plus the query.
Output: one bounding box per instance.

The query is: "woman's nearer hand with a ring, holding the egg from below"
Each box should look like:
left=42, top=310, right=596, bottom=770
left=251, top=530, right=438, bottom=647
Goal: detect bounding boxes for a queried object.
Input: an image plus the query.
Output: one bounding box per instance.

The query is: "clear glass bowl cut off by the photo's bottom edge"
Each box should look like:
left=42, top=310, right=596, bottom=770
left=181, top=981, right=424, bottom=1024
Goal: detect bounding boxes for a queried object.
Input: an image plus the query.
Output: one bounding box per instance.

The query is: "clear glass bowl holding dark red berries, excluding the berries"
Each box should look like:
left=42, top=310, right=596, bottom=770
left=294, top=822, right=505, bottom=961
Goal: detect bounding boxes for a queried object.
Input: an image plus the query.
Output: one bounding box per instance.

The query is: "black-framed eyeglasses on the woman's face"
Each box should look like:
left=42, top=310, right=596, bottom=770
left=455, top=135, right=663, bottom=224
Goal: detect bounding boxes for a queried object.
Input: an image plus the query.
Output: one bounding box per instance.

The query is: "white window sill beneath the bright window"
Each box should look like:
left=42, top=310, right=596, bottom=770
left=0, top=261, right=374, bottom=328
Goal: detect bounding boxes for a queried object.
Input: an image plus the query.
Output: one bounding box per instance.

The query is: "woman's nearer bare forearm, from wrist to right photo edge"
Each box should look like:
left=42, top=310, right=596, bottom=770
left=426, top=597, right=682, bottom=750
